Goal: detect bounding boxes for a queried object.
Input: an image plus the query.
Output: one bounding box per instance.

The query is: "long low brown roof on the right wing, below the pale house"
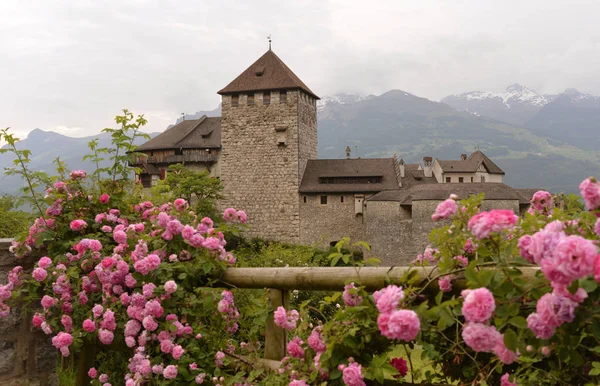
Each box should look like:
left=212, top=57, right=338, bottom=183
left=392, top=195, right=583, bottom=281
left=369, top=182, right=529, bottom=205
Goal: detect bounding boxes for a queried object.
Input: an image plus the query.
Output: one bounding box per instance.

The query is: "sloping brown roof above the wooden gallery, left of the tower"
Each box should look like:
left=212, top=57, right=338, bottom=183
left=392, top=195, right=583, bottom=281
left=136, top=115, right=221, bottom=151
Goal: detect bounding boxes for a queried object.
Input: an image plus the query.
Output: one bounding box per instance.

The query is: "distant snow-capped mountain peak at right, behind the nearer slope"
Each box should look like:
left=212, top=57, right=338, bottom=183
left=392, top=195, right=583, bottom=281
left=441, top=84, right=550, bottom=125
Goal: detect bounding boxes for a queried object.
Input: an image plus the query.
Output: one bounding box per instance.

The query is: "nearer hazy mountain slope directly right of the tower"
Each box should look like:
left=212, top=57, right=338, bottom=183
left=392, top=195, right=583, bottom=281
left=318, top=87, right=600, bottom=192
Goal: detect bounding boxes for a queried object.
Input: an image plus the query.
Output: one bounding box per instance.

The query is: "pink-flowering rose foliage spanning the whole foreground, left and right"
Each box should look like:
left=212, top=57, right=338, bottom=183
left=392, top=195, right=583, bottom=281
left=0, top=113, right=600, bottom=386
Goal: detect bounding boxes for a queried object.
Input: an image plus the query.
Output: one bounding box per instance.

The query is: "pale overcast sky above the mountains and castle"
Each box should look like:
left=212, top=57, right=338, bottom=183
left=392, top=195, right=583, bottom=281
left=0, top=0, right=600, bottom=136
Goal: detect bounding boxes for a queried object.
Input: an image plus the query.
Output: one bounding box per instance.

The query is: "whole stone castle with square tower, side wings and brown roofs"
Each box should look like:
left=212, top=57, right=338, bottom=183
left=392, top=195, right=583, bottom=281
left=136, top=49, right=533, bottom=265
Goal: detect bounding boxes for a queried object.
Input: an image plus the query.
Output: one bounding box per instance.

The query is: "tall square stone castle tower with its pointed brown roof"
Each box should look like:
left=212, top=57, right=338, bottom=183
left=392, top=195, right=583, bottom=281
left=219, top=49, right=319, bottom=242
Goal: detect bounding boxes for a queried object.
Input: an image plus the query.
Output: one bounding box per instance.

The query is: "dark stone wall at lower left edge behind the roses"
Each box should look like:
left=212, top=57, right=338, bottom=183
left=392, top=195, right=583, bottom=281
left=0, top=239, right=58, bottom=386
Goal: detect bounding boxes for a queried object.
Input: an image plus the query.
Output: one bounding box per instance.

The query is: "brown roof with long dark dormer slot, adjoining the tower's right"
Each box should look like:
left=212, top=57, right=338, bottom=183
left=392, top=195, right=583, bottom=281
left=299, top=158, right=398, bottom=193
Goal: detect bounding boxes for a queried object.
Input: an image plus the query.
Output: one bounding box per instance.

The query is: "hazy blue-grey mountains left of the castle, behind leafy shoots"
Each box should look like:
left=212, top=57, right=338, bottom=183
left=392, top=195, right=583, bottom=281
left=0, top=129, right=159, bottom=194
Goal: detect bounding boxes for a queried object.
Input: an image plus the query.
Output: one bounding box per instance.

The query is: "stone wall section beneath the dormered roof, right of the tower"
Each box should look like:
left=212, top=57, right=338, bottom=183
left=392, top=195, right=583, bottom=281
left=300, top=193, right=366, bottom=247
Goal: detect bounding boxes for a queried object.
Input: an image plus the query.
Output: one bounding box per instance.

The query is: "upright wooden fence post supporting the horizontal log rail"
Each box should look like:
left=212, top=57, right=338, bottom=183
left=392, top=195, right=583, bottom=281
left=265, top=288, right=290, bottom=361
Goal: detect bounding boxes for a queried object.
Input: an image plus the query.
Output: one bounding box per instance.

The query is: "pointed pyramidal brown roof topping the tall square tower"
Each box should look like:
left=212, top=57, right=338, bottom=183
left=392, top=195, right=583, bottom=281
left=218, top=50, right=319, bottom=99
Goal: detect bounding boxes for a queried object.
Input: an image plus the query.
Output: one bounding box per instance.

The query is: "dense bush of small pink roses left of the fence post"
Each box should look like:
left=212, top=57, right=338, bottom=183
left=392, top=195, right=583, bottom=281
left=0, top=167, right=253, bottom=385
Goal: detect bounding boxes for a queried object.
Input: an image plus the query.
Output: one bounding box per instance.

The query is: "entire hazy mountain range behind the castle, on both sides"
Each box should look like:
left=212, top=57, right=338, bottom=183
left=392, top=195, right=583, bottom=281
left=0, top=84, right=600, bottom=192
